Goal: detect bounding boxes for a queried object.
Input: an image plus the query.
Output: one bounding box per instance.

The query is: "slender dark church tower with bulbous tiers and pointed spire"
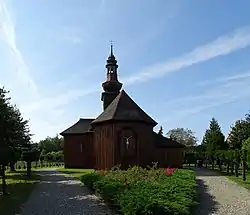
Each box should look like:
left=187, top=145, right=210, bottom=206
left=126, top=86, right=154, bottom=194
left=101, top=43, right=122, bottom=110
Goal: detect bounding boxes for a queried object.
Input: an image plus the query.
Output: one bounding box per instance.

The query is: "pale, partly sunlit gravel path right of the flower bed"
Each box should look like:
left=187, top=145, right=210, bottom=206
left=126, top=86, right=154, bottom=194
left=192, top=168, right=250, bottom=215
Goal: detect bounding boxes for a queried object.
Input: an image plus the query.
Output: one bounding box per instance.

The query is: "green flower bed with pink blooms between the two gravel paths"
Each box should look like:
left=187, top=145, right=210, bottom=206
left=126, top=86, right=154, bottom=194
left=82, top=166, right=197, bottom=215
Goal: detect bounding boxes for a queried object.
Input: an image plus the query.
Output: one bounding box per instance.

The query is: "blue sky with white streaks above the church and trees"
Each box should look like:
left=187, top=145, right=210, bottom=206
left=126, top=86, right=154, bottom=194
left=0, top=0, right=250, bottom=141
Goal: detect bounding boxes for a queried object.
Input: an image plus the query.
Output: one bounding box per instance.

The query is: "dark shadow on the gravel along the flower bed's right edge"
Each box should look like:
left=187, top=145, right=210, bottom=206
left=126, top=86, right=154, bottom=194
left=193, top=179, right=218, bottom=215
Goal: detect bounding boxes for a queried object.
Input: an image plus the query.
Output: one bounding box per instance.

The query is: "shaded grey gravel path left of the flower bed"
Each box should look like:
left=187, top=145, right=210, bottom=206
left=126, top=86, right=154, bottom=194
left=21, top=170, right=115, bottom=215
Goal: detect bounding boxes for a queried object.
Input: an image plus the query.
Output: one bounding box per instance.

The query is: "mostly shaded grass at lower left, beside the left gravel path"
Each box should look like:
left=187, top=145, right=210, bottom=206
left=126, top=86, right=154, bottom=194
left=0, top=170, right=40, bottom=215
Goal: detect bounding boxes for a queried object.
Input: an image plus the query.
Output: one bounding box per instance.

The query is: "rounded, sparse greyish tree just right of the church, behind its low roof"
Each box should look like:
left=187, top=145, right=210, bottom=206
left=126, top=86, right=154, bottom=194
left=167, top=128, right=197, bottom=147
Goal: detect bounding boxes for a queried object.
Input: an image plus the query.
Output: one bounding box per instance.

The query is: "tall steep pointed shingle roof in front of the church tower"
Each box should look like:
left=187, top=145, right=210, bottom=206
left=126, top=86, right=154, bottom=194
left=91, top=90, right=157, bottom=126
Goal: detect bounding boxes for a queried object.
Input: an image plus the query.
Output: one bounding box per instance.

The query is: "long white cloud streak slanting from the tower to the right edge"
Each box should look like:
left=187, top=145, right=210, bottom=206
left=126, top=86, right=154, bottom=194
left=124, top=26, right=250, bottom=85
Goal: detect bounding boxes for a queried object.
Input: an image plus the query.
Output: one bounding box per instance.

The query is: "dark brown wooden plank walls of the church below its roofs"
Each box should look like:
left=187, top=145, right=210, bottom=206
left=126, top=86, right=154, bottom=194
left=64, top=122, right=183, bottom=169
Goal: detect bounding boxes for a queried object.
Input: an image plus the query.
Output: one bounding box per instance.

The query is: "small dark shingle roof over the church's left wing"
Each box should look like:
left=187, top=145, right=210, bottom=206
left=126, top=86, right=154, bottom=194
left=60, top=118, right=94, bottom=136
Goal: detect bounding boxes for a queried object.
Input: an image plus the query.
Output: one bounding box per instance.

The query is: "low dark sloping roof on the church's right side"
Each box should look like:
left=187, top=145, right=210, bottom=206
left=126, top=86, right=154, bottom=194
left=154, top=132, right=186, bottom=148
